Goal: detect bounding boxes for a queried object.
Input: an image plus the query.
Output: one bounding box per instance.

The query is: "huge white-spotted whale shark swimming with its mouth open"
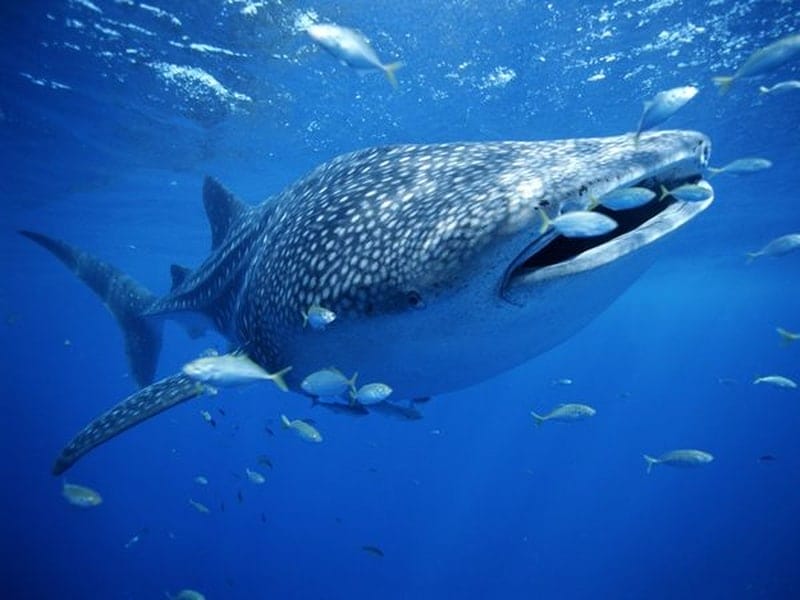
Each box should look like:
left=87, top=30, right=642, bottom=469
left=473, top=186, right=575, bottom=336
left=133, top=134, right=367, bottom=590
left=21, top=131, right=713, bottom=474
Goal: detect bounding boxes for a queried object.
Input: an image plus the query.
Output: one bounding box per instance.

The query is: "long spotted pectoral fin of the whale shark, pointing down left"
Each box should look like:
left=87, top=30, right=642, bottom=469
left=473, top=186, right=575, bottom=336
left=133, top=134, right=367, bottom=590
left=53, top=374, right=205, bottom=475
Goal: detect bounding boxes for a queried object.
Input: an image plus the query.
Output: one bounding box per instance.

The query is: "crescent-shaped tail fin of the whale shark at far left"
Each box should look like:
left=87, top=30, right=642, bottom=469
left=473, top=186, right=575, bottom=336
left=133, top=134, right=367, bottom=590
left=19, top=230, right=162, bottom=386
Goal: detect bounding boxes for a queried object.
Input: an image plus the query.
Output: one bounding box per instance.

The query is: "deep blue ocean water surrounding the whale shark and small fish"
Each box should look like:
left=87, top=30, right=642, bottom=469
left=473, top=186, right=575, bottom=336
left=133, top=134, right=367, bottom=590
left=0, top=0, right=800, bottom=599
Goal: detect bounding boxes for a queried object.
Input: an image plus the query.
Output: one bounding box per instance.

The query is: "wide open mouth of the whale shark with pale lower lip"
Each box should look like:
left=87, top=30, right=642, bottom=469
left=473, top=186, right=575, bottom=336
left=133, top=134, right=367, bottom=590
left=500, top=161, right=714, bottom=296
